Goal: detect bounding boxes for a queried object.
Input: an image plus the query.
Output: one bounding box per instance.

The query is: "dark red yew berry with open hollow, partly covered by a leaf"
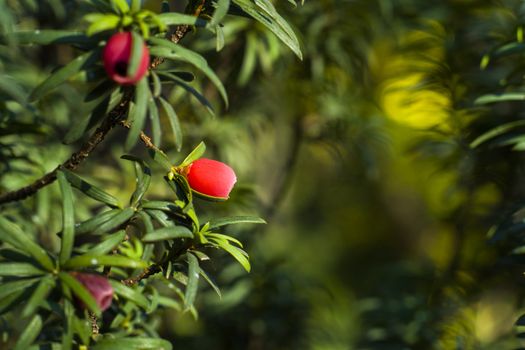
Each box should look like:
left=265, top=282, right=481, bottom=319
left=102, top=32, right=149, bottom=85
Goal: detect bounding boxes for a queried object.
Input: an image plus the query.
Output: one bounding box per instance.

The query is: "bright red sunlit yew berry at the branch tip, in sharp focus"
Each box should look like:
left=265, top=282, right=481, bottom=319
left=186, top=158, right=237, bottom=198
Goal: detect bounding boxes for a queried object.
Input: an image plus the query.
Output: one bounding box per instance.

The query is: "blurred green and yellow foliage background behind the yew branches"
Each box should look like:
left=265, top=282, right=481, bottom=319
left=5, top=0, right=525, bottom=350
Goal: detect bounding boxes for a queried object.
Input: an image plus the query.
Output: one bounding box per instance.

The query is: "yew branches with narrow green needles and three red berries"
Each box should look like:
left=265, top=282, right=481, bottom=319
left=0, top=0, right=301, bottom=349
